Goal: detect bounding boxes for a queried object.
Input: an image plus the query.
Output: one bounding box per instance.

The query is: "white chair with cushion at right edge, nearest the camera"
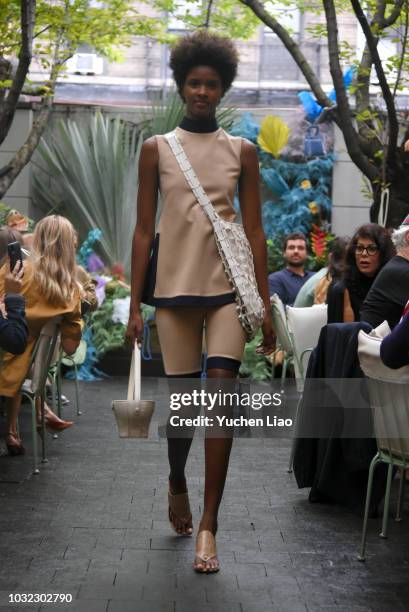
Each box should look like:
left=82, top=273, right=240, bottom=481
left=358, top=329, right=409, bottom=561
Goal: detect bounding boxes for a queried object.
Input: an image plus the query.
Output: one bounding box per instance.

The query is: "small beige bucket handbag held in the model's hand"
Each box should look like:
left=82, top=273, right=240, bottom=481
left=112, top=343, right=155, bottom=438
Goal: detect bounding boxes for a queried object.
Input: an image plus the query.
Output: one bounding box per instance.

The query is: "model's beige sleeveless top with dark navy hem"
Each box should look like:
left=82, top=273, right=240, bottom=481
left=147, top=128, right=242, bottom=306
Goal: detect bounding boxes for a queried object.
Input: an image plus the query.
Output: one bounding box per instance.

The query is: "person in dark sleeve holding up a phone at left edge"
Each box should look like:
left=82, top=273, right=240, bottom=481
left=0, top=228, right=28, bottom=354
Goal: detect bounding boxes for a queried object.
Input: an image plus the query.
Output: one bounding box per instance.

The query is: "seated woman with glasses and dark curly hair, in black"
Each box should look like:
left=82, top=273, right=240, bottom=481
left=327, top=223, right=395, bottom=323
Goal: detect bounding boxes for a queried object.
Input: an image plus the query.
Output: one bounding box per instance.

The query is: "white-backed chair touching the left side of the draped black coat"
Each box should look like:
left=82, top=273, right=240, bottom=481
left=287, top=304, right=328, bottom=473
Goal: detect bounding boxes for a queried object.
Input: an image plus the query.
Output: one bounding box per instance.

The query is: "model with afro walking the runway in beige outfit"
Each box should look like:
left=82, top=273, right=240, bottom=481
left=128, top=31, right=275, bottom=573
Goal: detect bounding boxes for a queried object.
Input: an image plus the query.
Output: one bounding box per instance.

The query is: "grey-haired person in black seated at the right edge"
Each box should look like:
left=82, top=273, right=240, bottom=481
left=360, top=215, right=409, bottom=329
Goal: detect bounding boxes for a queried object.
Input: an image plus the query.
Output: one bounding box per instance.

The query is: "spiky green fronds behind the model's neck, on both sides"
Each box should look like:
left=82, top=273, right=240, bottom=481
left=140, top=89, right=235, bottom=136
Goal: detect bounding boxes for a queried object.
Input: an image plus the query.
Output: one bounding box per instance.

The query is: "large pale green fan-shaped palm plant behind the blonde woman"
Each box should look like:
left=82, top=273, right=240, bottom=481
left=34, top=113, right=142, bottom=271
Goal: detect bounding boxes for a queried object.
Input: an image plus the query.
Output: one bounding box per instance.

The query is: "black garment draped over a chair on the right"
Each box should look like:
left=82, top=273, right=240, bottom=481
left=294, top=322, right=386, bottom=514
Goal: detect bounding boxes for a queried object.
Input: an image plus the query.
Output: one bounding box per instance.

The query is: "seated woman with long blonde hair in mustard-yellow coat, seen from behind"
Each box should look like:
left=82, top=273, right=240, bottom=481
left=0, top=215, right=81, bottom=455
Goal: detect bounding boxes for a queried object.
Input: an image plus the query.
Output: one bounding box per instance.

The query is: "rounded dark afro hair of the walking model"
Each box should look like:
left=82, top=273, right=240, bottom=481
left=169, top=30, right=239, bottom=93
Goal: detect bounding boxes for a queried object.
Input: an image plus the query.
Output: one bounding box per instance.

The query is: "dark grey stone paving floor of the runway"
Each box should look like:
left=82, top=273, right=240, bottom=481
left=0, top=379, right=409, bottom=612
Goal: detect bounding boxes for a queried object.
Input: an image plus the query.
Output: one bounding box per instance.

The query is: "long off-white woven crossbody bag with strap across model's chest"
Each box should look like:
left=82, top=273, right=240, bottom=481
left=165, top=132, right=264, bottom=341
